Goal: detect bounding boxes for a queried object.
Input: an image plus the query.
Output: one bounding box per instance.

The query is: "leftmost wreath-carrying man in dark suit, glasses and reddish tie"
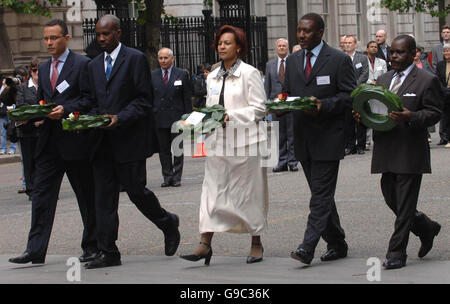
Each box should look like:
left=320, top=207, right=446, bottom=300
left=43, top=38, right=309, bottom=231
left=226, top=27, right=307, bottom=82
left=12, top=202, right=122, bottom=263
left=9, top=19, right=98, bottom=264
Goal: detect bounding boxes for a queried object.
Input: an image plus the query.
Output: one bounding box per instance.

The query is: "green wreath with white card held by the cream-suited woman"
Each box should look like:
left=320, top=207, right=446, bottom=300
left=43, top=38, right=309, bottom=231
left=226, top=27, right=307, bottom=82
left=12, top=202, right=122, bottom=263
left=175, top=105, right=226, bottom=139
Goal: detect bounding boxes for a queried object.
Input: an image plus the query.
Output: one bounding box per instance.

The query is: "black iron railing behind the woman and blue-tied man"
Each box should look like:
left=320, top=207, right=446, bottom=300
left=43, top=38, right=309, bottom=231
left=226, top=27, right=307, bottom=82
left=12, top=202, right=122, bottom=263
left=83, top=11, right=268, bottom=74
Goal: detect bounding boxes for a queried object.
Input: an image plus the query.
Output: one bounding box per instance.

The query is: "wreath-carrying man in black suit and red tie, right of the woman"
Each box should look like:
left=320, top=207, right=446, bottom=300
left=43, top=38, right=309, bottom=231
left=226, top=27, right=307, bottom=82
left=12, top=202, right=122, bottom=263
left=285, top=13, right=356, bottom=264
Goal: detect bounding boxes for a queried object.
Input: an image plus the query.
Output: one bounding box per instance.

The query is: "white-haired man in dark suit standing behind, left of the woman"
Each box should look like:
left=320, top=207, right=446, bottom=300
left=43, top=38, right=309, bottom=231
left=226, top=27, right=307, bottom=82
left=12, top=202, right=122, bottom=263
left=152, top=48, right=192, bottom=187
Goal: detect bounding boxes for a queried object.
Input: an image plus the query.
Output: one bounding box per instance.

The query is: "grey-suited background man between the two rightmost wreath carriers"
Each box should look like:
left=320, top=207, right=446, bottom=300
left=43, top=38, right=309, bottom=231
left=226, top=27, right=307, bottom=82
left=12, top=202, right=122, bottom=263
left=344, top=35, right=369, bottom=155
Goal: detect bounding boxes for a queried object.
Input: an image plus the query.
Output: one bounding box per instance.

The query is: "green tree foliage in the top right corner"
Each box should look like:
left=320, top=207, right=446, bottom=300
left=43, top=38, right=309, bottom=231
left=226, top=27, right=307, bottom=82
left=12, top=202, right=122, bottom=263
left=380, top=0, right=450, bottom=17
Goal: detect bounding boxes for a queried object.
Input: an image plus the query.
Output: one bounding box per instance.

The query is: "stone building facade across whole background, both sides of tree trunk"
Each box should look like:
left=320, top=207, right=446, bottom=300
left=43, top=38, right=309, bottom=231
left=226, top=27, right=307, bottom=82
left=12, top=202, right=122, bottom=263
left=3, top=0, right=450, bottom=72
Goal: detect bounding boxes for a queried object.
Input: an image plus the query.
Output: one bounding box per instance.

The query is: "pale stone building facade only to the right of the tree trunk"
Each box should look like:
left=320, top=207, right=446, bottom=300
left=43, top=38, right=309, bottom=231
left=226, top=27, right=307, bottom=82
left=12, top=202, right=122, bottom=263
left=164, top=0, right=449, bottom=58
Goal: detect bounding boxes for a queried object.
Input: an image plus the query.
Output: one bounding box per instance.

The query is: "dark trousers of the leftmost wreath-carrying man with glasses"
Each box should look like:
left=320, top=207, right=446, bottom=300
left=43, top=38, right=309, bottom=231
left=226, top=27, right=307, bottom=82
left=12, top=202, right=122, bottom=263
left=27, top=144, right=97, bottom=257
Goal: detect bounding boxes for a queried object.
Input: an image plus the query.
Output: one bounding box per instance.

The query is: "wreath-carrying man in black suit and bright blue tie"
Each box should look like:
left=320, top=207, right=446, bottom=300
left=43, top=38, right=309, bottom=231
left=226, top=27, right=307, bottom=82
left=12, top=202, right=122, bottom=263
left=86, top=15, right=180, bottom=269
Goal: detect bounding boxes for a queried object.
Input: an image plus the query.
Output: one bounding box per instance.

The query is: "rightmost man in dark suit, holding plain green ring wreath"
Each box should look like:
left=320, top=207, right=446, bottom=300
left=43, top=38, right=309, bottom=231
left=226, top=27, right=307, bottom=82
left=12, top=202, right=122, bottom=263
left=355, top=35, right=444, bottom=269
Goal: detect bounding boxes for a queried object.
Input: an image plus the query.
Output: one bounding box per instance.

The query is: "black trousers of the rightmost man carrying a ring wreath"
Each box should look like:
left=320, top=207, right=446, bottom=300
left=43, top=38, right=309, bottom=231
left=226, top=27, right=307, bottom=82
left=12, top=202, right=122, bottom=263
left=381, top=173, right=438, bottom=258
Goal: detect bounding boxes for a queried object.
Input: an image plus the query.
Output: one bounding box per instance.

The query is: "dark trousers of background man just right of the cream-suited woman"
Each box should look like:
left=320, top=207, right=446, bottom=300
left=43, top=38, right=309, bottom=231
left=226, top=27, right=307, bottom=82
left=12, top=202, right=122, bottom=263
left=276, top=113, right=298, bottom=167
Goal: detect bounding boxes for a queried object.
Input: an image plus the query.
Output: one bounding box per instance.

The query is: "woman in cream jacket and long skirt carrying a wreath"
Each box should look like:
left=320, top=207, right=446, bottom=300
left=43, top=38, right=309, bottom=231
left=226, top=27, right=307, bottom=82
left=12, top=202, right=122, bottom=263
left=181, top=25, right=268, bottom=265
